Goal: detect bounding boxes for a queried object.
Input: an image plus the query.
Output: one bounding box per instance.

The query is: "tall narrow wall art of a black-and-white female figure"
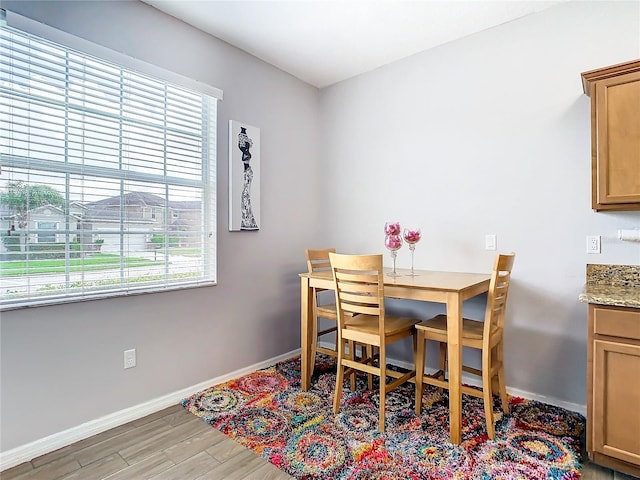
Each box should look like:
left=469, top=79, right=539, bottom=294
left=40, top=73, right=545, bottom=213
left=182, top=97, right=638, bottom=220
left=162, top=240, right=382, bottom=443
left=229, top=120, right=260, bottom=232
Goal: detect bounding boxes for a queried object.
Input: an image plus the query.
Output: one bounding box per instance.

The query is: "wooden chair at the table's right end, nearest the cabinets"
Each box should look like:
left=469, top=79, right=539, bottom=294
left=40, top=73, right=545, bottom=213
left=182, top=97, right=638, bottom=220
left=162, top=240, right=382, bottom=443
left=415, top=253, right=515, bottom=440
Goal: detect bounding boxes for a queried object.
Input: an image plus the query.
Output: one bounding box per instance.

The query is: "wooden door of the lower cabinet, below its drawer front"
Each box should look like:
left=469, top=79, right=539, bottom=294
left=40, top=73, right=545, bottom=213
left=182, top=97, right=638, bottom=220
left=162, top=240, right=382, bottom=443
left=593, top=340, right=640, bottom=465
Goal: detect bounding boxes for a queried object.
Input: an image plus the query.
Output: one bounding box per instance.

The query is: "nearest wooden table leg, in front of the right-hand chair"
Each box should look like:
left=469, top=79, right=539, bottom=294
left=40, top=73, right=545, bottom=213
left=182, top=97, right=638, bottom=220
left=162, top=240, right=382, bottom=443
left=447, top=293, right=462, bottom=444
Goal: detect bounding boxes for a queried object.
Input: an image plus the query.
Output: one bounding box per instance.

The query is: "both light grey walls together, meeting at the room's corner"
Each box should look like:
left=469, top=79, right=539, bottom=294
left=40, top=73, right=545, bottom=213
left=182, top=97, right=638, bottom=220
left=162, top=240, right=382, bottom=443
left=0, top=1, right=640, bottom=464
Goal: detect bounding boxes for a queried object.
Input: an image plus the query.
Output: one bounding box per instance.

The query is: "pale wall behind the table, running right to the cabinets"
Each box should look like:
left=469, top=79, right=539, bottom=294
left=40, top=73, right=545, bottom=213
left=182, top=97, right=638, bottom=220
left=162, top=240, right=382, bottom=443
left=321, top=2, right=640, bottom=405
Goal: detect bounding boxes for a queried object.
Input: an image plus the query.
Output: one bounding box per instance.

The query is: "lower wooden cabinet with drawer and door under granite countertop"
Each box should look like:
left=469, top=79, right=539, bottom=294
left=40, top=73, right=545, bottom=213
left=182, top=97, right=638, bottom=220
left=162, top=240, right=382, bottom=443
left=587, top=304, right=640, bottom=476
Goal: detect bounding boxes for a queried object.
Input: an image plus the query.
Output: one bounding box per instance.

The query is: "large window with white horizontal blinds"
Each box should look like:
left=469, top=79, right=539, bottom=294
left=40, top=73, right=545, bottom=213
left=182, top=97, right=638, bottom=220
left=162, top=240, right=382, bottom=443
left=0, top=21, right=217, bottom=309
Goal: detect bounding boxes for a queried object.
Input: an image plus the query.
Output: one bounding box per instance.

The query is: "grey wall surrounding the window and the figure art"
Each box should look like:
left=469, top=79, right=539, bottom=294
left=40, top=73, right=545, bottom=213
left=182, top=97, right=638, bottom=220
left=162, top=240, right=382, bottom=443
left=0, top=1, right=320, bottom=452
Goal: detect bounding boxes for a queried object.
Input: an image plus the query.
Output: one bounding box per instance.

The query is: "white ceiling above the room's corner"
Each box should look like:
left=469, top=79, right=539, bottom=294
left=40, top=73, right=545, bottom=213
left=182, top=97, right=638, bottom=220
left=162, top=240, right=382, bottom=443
left=142, top=0, right=568, bottom=88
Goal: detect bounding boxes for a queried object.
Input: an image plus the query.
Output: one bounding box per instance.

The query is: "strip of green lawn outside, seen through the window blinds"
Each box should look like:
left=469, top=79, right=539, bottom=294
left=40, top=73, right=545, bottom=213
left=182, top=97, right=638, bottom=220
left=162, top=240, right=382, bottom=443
left=0, top=253, right=164, bottom=276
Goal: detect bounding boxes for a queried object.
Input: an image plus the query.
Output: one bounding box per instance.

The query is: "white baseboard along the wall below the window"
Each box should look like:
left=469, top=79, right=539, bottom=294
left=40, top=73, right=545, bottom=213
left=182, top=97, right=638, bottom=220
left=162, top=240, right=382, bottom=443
left=0, top=349, right=300, bottom=472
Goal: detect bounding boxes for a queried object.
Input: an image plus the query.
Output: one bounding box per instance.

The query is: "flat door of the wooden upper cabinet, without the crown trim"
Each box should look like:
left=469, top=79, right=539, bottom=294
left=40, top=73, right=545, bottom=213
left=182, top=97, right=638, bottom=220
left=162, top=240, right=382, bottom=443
left=594, top=72, right=640, bottom=205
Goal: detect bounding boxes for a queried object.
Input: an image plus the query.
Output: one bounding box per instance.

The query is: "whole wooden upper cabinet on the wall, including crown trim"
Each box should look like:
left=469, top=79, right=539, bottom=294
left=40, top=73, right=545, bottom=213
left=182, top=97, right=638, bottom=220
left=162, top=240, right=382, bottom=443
left=582, top=60, right=640, bottom=210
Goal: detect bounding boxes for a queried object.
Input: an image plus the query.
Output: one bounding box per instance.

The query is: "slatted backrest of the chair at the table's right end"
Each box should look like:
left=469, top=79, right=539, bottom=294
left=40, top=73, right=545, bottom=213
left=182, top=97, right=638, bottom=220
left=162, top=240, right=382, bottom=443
left=483, top=253, right=515, bottom=341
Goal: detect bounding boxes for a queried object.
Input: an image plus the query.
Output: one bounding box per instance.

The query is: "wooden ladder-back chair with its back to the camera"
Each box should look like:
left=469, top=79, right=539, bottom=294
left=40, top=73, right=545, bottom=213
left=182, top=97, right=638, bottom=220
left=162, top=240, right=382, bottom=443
left=329, top=253, right=420, bottom=432
